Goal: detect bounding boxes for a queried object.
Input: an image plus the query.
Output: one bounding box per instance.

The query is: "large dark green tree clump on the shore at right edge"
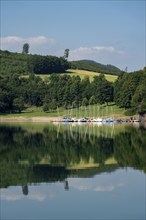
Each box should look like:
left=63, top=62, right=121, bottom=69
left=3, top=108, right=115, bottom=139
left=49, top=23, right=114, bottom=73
left=114, top=69, right=146, bottom=114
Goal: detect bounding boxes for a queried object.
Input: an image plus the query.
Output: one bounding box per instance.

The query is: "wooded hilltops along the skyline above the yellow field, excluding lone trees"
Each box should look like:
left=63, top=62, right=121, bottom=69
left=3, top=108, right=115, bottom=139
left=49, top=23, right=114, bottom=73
left=0, top=50, right=122, bottom=76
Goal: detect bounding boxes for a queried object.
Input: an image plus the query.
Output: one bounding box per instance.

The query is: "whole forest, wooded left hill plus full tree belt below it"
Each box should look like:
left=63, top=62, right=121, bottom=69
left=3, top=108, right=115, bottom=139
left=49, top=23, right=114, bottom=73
left=0, top=51, right=146, bottom=114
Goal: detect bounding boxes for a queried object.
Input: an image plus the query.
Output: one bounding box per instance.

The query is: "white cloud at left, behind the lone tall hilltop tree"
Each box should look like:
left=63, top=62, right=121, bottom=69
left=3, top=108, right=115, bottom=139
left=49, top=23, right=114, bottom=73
left=0, top=36, right=56, bottom=52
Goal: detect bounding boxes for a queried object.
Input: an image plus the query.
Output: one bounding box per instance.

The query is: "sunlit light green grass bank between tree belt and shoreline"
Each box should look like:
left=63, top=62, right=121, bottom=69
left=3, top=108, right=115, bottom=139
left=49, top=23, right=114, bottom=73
left=2, top=104, right=125, bottom=118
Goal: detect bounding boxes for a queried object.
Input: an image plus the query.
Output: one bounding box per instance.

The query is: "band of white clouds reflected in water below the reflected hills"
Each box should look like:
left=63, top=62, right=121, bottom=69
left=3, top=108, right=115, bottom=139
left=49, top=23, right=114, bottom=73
left=1, top=168, right=141, bottom=201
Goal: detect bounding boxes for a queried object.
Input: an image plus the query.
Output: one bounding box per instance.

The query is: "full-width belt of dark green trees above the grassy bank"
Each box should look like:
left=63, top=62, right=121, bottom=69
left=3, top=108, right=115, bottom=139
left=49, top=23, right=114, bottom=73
left=0, top=68, right=146, bottom=114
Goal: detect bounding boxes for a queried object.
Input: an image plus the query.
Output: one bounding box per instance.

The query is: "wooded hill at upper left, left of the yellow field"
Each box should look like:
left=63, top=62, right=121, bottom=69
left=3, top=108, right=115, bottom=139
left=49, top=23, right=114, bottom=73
left=0, top=50, right=70, bottom=75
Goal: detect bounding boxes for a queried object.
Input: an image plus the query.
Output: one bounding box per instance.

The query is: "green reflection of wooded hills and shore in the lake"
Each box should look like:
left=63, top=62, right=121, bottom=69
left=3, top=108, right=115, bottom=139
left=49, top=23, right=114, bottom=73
left=0, top=124, right=146, bottom=191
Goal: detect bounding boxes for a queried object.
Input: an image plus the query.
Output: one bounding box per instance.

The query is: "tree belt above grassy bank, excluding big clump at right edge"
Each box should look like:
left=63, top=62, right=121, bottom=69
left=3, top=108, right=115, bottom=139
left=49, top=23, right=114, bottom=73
left=0, top=74, right=113, bottom=113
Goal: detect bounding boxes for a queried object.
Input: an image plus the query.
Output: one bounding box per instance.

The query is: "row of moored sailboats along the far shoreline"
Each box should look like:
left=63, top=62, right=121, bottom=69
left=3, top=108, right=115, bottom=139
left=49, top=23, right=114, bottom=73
left=62, top=117, right=140, bottom=123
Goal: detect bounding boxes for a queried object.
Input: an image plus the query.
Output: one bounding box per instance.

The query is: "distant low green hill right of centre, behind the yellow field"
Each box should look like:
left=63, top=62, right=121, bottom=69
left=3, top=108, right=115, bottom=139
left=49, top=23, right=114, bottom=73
left=70, top=60, right=122, bottom=75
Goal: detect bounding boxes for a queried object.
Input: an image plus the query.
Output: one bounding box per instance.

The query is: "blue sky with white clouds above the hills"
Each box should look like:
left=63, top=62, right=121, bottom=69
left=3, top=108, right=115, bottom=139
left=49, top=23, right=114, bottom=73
left=1, top=0, right=146, bottom=71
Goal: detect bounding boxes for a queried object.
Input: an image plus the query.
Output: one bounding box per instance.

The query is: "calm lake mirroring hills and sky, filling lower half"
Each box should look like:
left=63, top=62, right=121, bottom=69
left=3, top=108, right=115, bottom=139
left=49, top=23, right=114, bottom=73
left=0, top=123, right=146, bottom=220
